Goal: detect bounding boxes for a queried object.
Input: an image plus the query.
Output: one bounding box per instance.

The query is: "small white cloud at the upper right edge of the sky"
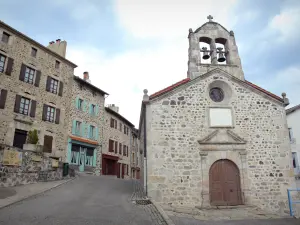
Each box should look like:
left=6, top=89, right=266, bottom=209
left=269, top=6, right=300, bottom=41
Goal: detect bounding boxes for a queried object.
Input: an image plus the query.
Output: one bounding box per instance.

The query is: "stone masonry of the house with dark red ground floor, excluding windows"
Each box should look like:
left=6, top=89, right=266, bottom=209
left=102, top=111, right=132, bottom=179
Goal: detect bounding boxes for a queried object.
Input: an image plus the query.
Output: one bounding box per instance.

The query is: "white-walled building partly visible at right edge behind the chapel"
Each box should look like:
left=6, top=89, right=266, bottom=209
left=286, top=105, right=300, bottom=179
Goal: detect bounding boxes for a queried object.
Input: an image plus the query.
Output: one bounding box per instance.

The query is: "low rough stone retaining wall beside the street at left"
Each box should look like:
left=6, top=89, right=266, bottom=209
left=0, top=145, right=70, bottom=187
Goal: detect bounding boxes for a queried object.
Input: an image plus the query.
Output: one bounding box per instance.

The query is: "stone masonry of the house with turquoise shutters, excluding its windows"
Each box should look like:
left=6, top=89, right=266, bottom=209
left=67, top=79, right=105, bottom=175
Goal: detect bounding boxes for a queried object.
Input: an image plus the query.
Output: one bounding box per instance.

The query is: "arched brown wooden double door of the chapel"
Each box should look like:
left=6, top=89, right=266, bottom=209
left=209, top=159, right=242, bottom=205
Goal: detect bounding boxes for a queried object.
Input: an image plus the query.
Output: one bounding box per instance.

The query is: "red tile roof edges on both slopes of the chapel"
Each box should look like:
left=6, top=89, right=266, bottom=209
left=150, top=78, right=283, bottom=101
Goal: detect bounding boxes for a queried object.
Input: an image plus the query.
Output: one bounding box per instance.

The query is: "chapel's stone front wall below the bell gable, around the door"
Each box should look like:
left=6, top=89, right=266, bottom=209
left=146, top=72, right=294, bottom=212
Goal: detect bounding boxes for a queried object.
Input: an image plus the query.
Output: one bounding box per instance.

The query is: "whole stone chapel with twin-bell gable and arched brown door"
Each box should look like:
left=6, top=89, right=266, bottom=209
left=139, top=16, right=295, bottom=212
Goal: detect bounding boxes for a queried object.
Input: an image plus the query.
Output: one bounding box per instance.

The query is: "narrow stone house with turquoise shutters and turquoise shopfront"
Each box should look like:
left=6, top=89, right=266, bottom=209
left=66, top=72, right=108, bottom=175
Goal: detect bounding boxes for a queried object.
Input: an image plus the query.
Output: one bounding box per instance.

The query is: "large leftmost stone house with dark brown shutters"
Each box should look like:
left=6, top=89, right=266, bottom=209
left=0, top=21, right=76, bottom=159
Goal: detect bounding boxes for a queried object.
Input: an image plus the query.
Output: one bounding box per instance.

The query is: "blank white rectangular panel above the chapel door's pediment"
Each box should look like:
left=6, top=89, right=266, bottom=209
left=209, top=108, right=233, bottom=127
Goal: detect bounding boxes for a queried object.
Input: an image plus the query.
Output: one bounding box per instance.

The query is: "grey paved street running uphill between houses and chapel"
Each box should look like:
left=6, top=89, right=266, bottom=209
left=0, top=176, right=161, bottom=225
